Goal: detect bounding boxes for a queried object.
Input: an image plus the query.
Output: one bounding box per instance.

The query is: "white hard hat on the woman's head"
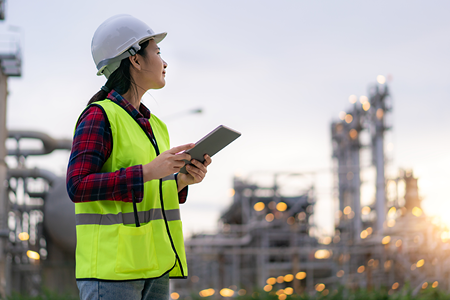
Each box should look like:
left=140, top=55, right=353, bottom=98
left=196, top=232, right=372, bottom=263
left=91, top=15, right=167, bottom=78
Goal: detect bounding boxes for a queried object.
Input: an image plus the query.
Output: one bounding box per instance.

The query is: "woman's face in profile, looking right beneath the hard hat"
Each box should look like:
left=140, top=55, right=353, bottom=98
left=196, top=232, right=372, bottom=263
left=140, top=40, right=167, bottom=89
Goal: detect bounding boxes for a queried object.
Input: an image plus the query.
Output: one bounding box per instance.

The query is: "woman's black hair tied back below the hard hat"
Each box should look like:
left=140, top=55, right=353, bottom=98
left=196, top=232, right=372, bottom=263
left=87, top=41, right=149, bottom=105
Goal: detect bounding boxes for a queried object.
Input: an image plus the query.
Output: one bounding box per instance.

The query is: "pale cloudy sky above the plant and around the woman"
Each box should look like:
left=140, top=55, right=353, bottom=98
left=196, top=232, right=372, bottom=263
left=0, top=0, right=450, bottom=235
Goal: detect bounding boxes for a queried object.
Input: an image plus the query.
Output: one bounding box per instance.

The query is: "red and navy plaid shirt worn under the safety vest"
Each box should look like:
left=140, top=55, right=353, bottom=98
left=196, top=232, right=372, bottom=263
left=66, top=90, right=188, bottom=203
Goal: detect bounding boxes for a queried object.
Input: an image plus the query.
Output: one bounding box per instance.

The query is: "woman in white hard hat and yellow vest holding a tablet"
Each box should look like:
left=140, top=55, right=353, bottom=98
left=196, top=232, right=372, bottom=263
left=67, top=15, right=211, bottom=300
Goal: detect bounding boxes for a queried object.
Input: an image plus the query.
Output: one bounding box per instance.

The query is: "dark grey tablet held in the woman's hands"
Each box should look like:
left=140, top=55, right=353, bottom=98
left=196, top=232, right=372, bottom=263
left=180, top=125, right=241, bottom=174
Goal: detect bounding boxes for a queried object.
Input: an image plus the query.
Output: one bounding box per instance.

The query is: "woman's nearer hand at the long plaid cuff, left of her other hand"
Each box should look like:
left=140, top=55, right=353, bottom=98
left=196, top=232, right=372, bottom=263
left=142, top=144, right=195, bottom=182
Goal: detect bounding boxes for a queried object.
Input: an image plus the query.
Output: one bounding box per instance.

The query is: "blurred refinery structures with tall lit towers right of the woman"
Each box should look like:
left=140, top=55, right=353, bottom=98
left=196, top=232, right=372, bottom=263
left=172, top=78, right=450, bottom=300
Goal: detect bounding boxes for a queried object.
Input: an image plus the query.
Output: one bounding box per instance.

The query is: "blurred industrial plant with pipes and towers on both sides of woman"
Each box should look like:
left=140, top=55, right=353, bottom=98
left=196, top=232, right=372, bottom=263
left=0, top=1, right=450, bottom=300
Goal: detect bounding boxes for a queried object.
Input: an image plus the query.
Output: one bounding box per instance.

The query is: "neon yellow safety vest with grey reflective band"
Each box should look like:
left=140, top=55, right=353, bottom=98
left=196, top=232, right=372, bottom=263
left=75, top=99, right=187, bottom=280
